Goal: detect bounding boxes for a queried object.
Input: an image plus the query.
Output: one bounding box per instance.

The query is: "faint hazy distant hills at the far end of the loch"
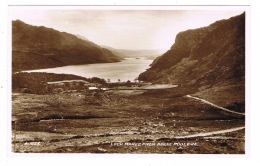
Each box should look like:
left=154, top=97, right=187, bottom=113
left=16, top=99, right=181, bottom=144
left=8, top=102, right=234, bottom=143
left=102, top=46, right=164, bottom=59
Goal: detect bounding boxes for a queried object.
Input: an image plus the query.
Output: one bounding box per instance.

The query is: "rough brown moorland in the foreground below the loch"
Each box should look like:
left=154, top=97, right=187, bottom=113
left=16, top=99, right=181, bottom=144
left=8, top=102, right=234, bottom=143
left=12, top=87, right=245, bottom=154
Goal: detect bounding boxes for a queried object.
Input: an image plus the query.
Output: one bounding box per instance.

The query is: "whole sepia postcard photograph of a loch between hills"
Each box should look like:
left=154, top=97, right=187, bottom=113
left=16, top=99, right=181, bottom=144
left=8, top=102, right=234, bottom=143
left=8, top=5, right=248, bottom=155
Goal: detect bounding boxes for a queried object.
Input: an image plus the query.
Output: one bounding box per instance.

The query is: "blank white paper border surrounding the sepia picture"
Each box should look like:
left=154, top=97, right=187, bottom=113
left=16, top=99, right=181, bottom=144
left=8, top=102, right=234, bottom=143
left=0, top=0, right=260, bottom=166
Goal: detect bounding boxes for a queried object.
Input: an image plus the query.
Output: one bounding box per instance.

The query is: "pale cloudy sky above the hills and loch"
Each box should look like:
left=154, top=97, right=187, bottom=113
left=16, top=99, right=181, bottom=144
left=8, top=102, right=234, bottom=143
left=9, top=6, right=244, bottom=50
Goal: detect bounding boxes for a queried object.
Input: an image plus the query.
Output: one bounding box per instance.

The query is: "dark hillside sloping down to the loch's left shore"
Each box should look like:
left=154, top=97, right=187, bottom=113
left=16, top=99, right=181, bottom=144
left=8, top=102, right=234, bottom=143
left=12, top=20, right=122, bottom=71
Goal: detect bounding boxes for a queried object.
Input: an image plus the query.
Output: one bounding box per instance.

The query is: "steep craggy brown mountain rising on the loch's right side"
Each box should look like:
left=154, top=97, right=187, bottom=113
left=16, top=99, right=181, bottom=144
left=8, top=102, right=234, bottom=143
left=139, top=13, right=245, bottom=109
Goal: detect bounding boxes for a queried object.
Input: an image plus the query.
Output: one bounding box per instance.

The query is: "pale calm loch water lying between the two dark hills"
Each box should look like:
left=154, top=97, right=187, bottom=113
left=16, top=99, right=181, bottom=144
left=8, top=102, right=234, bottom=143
left=26, top=58, right=152, bottom=82
